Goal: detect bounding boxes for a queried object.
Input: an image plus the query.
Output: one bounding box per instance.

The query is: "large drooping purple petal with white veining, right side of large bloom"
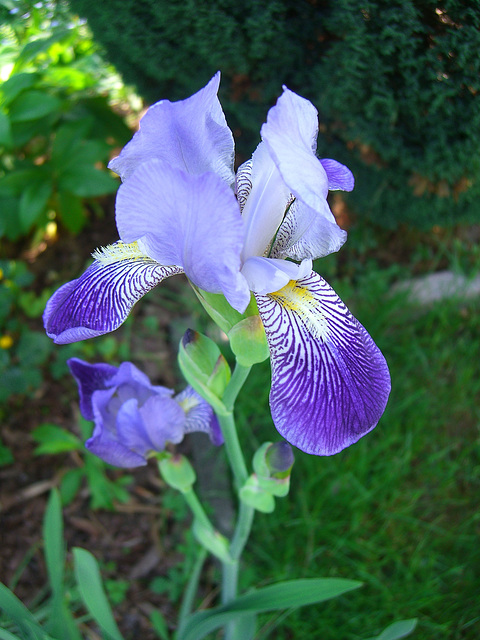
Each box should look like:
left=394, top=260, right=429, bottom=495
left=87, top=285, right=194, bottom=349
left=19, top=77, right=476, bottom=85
left=256, top=272, right=390, bottom=455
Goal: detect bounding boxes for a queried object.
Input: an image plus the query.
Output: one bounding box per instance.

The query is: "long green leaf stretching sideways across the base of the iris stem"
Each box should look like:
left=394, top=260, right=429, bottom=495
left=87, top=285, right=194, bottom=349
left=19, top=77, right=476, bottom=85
left=179, top=578, right=362, bottom=640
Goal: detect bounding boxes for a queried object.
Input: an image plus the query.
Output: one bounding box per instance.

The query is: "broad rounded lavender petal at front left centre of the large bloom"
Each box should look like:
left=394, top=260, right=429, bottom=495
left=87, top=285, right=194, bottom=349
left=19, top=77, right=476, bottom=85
left=116, top=160, right=250, bottom=313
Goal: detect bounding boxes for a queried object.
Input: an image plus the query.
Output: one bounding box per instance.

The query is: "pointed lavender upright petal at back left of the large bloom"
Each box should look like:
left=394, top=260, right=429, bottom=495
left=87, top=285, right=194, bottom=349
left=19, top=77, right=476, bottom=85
left=109, top=73, right=234, bottom=185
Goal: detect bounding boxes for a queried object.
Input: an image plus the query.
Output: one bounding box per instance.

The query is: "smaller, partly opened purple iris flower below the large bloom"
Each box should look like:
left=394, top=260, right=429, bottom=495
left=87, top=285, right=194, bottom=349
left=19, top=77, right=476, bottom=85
left=68, top=358, right=223, bottom=467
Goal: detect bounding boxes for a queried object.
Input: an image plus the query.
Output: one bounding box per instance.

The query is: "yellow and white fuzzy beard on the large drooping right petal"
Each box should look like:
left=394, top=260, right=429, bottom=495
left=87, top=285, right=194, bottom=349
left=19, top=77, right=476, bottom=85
left=267, top=280, right=329, bottom=340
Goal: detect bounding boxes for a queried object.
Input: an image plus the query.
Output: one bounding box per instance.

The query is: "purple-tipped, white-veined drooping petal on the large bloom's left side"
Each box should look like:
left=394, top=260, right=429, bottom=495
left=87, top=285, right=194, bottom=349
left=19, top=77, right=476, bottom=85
left=43, top=242, right=182, bottom=344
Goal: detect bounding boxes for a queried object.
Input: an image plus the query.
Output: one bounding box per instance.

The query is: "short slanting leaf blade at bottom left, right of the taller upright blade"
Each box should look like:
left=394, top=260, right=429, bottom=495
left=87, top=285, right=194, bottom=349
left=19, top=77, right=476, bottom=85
left=73, top=547, right=123, bottom=640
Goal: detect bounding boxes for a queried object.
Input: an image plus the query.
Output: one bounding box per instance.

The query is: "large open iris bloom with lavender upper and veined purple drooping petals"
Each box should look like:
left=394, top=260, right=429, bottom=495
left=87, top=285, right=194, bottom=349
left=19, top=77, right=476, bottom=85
left=44, top=74, right=390, bottom=455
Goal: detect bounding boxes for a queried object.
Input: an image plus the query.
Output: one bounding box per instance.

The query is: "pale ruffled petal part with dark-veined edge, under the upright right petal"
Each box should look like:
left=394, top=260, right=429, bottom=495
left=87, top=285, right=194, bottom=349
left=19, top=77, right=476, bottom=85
left=271, top=200, right=347, bottom=260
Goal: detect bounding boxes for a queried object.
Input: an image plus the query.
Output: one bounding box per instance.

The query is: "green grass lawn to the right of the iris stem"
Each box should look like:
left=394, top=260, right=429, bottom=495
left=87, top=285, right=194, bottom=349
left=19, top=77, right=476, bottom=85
left=235, top=262, right=480, bottom=640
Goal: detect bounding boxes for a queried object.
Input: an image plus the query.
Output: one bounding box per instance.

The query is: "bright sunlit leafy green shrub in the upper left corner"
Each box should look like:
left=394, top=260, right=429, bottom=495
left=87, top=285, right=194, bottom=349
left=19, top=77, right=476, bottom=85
left=0, top=2, right=130, bottom=241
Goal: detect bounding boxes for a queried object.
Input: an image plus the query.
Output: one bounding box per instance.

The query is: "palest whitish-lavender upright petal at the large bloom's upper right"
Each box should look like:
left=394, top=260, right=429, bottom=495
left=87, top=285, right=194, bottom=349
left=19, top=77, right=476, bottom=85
left=261, top=87, right=333, bottom=210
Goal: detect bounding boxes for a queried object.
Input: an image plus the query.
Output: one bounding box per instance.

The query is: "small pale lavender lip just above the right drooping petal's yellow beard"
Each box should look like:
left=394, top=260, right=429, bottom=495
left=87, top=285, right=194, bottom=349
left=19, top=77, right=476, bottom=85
left=242, top=257, right=312, bottom=294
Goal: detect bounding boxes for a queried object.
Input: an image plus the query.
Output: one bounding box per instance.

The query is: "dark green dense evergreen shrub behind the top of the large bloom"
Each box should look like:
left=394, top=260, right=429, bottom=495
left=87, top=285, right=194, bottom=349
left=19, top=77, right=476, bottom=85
left=70, top=0, right=480, bottom=227
